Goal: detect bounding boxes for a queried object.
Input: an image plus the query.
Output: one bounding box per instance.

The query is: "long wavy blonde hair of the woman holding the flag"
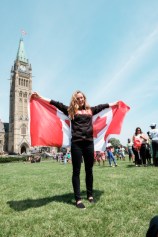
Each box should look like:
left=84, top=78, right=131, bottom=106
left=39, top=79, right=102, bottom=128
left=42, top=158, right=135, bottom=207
left=68, top=91, right=90, bottom=119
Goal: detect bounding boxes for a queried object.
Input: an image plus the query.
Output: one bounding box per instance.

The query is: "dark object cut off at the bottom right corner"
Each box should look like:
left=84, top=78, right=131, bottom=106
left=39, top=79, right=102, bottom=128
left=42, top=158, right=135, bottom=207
left=146, top=216, right=158, bottom=237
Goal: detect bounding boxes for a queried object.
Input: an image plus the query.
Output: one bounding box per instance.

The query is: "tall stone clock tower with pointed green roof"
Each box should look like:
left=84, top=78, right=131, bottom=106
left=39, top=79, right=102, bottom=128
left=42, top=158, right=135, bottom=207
left=8, top=39, right=32, bottom=154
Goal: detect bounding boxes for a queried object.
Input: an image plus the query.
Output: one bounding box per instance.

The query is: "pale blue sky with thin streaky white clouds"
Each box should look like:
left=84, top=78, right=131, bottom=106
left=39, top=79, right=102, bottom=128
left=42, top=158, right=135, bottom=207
left=0, top=0, right=158, bottom=145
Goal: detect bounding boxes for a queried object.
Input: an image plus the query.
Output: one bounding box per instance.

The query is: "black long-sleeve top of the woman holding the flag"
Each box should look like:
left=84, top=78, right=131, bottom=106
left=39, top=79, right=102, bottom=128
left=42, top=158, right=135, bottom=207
left=50, top=100, right=109, bottom=142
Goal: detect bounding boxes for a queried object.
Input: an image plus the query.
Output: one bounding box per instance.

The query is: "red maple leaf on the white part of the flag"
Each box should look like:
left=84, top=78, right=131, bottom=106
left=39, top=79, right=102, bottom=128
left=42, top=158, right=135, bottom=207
left=93, top=117, right=107, bottom=138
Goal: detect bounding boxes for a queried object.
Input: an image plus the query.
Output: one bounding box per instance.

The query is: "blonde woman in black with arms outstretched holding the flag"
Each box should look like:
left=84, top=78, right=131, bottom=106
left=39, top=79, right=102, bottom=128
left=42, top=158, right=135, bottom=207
left=32, top=91, right=118, bottom=209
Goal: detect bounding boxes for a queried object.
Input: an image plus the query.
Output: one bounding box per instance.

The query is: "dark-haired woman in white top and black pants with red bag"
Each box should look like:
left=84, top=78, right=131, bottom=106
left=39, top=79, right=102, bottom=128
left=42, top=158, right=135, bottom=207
left=133, top=127, right=148, bottom=166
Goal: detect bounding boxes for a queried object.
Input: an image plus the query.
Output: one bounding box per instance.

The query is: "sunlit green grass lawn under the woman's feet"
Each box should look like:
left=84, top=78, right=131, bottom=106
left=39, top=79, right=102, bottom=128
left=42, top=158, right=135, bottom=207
left=0, top=158, right=158, bottom=237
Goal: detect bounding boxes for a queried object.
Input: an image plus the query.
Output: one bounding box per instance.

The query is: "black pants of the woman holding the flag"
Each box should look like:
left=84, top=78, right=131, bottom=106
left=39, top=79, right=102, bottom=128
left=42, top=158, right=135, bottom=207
left=71, top=141, right=94, bottom=201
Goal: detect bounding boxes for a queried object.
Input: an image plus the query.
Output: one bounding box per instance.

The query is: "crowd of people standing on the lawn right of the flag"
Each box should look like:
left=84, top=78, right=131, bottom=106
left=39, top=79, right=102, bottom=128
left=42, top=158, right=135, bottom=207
left=94, top=123, right=158, bottom=167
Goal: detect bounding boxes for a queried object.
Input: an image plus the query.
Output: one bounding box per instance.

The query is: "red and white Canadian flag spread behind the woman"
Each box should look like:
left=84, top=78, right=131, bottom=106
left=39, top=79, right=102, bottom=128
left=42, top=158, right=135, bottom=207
left=29, top=97, right=130, bottom=151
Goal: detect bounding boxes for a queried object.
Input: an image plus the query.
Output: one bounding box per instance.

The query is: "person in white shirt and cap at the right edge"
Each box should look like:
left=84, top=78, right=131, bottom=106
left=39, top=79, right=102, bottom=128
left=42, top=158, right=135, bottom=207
left=148, top=123, right=158, bottom=166
